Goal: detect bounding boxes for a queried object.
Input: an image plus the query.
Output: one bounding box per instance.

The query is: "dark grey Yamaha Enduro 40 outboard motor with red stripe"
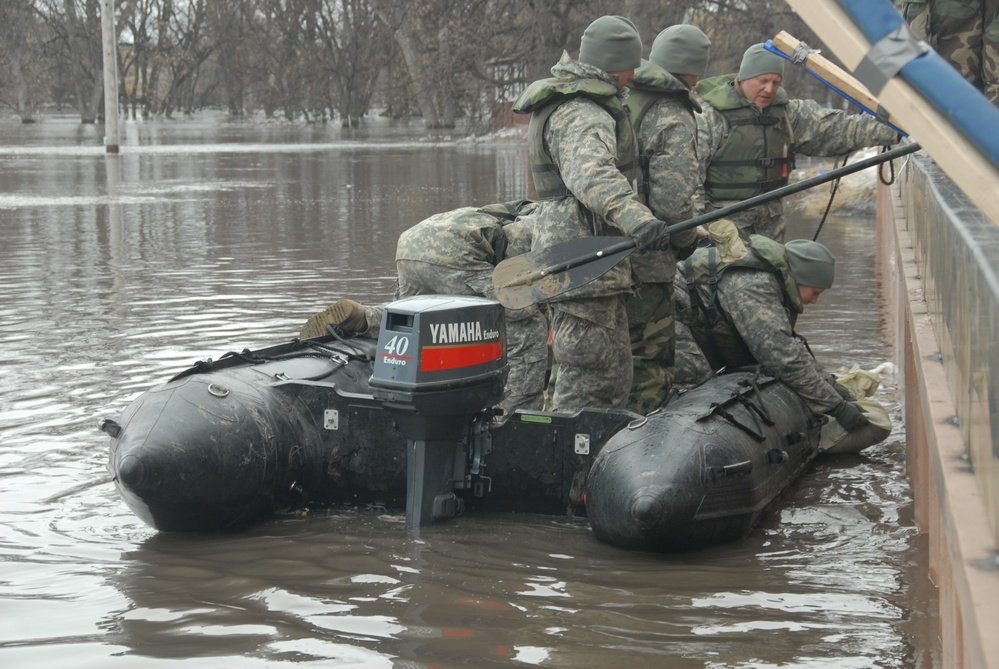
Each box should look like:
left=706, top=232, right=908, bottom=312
left=369, top=295, right=507, bottom=527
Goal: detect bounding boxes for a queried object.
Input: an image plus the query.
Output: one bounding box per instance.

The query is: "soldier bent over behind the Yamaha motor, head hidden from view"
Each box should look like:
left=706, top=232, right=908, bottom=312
left=301, top=200, right=548, bottom=413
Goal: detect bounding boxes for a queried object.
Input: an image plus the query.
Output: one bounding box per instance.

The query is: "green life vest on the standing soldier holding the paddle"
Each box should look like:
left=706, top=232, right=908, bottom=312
left=513, top=77, right=638, bottom=200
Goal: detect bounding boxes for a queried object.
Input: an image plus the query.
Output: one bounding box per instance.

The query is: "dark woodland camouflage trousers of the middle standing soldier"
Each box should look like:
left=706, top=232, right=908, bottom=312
left=626, top=283, right=676, bottom=415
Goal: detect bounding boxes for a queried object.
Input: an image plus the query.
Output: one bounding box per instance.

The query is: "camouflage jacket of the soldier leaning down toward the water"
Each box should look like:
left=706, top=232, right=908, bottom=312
left=676, top=238, right=843, bottom=413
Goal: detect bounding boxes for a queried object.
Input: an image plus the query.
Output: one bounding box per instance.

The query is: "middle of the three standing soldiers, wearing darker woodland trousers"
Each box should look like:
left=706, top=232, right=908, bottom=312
left=627, top=25, right=711, bottom=414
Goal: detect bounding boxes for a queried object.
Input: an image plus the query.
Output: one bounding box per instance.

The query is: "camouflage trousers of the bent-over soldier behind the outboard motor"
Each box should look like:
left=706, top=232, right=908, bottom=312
left=396, top=260, right=548, bottom=414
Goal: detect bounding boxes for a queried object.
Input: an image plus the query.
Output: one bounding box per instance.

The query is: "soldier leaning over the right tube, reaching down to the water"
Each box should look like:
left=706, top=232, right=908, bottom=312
left=676, top=235, right=868, bottom=432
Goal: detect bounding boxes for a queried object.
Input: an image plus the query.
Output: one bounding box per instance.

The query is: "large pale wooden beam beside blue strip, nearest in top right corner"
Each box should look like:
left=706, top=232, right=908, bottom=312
left=787, top=0, right=999, bottom=226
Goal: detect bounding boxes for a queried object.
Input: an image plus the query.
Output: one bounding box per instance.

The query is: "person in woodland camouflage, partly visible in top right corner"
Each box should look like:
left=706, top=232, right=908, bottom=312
left=895, top=0, right=999, bottom=105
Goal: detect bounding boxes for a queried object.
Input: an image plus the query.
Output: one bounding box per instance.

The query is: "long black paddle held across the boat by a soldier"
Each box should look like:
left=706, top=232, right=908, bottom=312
left=493, top=142, right=920, bottom=309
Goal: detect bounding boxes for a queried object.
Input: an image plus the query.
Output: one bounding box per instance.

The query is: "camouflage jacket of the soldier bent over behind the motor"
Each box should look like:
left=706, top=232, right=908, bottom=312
left=395, top=200, right=537, bottom=271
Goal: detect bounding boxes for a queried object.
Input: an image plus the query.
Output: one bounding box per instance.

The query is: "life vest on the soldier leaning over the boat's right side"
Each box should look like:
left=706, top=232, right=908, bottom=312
left=678, top=235, right=804, bottom=369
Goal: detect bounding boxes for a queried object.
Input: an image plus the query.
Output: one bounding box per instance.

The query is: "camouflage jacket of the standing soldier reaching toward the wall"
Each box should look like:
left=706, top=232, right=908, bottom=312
left=697, top=74, right=898, bottom=241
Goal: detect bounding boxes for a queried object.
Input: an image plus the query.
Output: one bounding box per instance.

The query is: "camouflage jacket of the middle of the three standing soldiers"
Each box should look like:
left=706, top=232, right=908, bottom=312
left=627, top=60, right=701, bottom=283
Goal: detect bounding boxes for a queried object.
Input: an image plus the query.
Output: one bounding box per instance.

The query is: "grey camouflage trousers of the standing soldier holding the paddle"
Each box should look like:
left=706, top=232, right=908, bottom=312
left=549, top=295, right=633, bottom=413
